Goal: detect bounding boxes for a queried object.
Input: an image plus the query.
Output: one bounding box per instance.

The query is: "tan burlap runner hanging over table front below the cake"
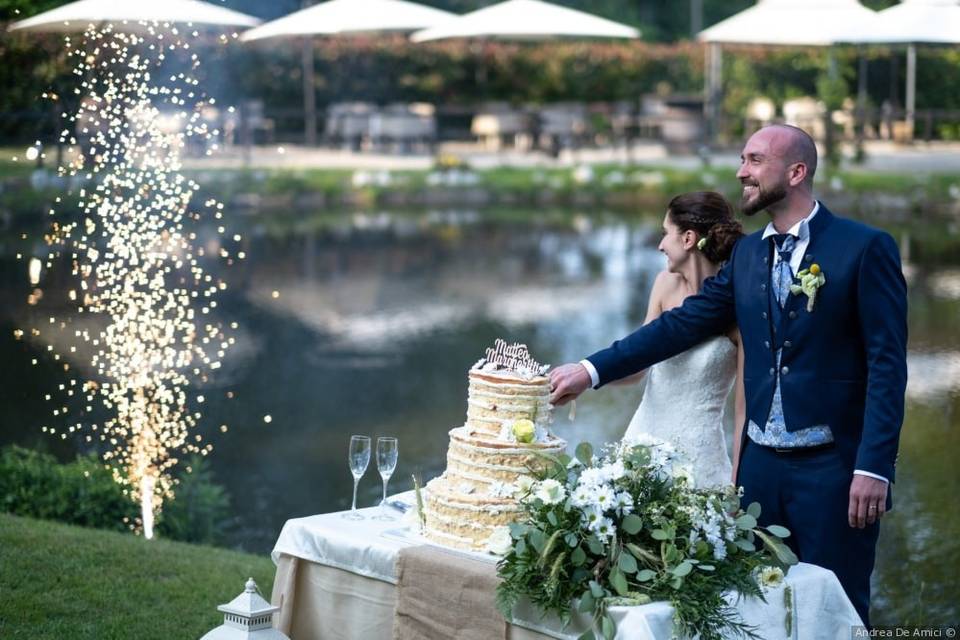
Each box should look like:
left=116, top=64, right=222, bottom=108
left=393, top=545, right=507, bottom=640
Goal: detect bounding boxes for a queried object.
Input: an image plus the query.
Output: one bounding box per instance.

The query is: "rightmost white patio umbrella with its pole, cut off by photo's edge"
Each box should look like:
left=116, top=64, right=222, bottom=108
left=844, top=0, right=960, bottom=135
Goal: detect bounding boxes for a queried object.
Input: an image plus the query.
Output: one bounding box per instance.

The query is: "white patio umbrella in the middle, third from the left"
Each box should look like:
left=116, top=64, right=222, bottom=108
left=410, top=0, right=640, bottom=42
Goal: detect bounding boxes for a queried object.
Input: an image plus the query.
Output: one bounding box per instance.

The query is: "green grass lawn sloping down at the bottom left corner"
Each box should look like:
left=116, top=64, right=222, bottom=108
left=0, top=514, right=274, bottom=640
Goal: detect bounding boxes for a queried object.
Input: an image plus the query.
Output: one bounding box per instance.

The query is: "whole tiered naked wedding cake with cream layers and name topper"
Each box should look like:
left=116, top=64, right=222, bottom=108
left=424, top=340, right=567, bottom=551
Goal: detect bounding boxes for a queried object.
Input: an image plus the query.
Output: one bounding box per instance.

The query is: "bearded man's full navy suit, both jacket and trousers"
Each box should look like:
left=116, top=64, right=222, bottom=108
left=588, top=204, right=907, bottom=622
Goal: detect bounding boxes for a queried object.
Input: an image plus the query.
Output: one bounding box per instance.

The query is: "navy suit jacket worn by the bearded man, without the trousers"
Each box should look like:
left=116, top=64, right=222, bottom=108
left=588, top=203, right=907, bottom=482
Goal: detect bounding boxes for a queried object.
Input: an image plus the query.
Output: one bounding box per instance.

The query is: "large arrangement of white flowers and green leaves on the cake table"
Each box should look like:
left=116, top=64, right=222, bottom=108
left=491, top=441, right=797, bottom=640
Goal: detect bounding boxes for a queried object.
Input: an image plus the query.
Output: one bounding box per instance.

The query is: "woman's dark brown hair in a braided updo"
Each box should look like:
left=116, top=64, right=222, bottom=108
left=667, top=191, right=743, bottom=264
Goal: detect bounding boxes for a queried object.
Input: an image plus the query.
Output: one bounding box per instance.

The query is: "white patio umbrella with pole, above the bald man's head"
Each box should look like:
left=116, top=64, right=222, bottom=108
left=697, top=0, right=878, bottom=142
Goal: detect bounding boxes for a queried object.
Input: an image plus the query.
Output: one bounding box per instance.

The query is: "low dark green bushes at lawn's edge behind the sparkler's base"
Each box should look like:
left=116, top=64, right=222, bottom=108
left=0, top=446, right=229, bottom=543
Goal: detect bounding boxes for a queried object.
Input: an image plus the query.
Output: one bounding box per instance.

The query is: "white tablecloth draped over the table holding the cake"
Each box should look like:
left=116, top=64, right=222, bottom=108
left=271, top=492, right=862, bottom=640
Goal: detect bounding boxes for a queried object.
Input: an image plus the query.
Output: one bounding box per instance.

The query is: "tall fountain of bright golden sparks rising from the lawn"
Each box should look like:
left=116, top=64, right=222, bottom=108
left=21, top=23, right=243, bottom=538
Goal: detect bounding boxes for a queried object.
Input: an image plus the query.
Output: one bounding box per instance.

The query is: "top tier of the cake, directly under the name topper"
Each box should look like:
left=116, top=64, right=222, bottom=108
left=466, top=369, right=551, bottom=435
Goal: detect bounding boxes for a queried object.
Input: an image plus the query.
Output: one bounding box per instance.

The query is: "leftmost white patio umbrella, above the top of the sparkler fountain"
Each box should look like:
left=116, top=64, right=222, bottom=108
left=9, top=0, right=260, bottom=33
